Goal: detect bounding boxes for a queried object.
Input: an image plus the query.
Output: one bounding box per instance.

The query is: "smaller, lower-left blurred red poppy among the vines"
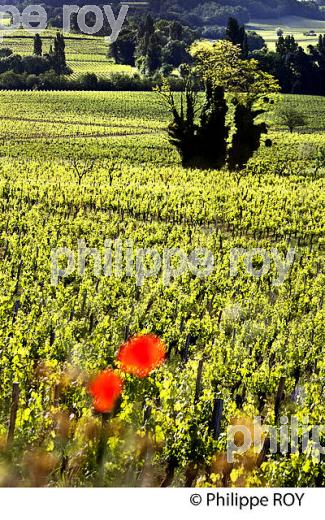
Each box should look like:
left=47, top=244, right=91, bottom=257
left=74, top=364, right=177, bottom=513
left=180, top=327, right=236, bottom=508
left=89, top=370, right=123, bottom=413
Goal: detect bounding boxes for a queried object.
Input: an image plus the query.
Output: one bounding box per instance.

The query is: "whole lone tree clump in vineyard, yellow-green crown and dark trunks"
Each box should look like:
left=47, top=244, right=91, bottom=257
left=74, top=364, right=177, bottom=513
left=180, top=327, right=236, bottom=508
left=160, top=40, right=280, bottom=171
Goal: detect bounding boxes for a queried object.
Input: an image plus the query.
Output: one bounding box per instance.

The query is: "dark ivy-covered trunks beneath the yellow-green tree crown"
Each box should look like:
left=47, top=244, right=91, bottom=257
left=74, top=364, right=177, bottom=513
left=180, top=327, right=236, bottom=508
left=160, top=79, right=273, bottom=171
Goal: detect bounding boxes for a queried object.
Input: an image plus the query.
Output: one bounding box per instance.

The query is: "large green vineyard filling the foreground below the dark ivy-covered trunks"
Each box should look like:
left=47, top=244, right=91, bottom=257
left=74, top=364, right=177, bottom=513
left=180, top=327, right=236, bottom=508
left=0, top=92, right=325, bottom=487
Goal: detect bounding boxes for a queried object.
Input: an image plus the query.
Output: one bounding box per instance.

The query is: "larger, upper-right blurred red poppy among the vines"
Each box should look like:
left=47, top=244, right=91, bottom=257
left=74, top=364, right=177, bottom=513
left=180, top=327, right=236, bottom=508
left=117, top=334, right=166, bottom=378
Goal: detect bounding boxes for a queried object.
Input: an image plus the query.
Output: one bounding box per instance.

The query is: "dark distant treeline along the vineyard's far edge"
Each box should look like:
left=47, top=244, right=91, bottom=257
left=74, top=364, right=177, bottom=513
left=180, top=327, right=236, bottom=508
left=0, top=15, right=325, bottom=96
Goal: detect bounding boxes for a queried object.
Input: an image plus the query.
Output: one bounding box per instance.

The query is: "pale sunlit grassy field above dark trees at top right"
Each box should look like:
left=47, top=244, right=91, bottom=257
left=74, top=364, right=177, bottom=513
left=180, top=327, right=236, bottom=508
left=246, top=16, right=325, bottom=50
